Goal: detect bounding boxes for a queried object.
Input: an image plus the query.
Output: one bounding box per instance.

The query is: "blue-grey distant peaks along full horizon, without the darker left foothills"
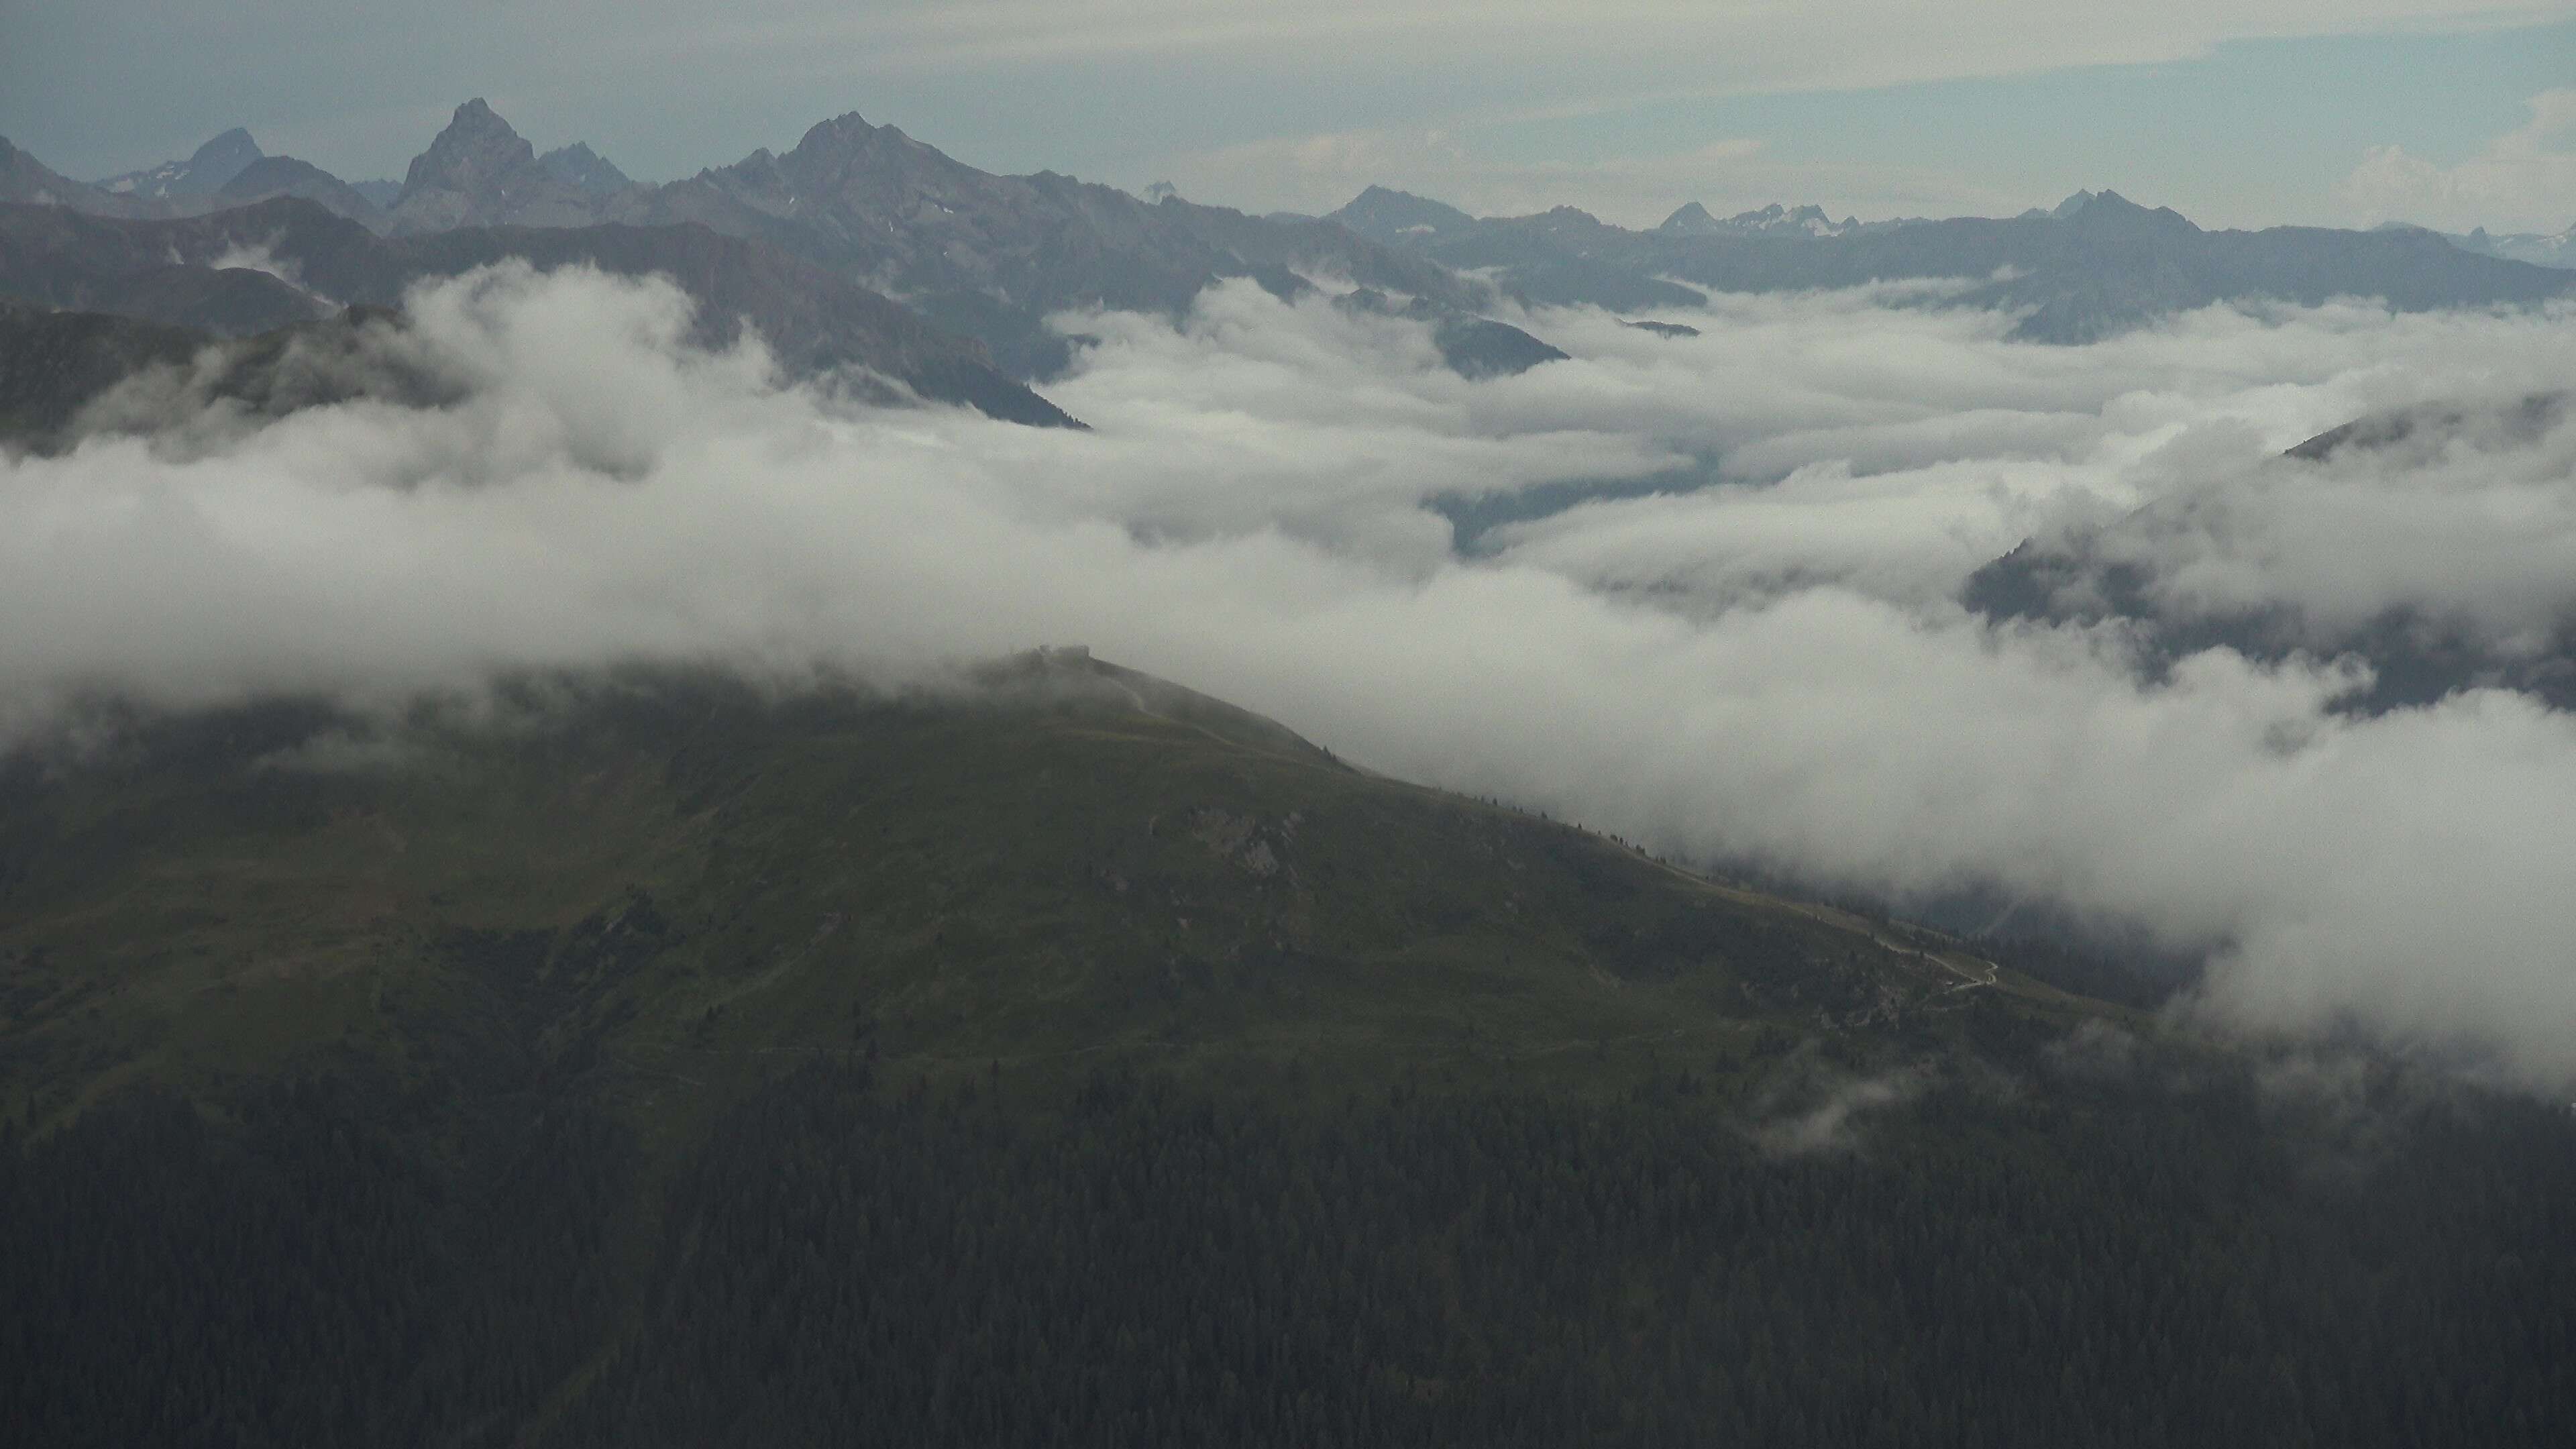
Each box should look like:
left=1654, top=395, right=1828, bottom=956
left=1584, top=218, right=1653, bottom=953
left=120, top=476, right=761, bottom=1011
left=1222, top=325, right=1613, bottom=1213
left=0, top=112, right=2576, bottom=366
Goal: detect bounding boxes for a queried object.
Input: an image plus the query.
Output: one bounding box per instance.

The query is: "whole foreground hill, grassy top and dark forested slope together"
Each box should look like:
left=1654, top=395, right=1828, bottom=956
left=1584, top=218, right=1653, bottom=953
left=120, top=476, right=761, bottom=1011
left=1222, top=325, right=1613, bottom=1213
left=0, top=652, right=2576, bottom=1446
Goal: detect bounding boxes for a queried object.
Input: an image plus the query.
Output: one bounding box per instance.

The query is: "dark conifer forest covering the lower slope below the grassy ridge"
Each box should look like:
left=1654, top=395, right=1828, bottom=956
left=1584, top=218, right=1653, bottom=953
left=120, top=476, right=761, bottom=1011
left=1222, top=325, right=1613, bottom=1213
left=0, top=1041, right=2576, bottom=1446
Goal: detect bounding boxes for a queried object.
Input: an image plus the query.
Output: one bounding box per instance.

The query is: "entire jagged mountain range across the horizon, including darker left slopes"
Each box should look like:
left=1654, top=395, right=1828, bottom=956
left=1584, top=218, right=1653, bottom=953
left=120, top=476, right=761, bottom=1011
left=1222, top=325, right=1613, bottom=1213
left=15, top=98, right=2576, bottom=420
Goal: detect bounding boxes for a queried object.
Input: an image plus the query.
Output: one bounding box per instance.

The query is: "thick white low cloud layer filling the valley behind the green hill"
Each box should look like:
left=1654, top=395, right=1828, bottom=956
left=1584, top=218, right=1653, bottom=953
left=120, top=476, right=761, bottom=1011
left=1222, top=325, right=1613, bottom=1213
left=0, top=271, right=2576, bottom=1080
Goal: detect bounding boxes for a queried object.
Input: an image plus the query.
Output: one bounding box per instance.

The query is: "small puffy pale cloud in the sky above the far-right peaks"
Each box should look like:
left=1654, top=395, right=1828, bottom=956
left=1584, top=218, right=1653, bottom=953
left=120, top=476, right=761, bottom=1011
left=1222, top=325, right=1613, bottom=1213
left=2342, top=88, right=2576, bottom=235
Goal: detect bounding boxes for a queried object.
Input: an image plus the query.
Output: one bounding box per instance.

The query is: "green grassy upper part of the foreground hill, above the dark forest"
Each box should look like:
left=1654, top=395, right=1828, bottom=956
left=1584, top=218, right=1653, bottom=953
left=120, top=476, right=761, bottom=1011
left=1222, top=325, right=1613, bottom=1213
left=0, top=652, right=2102, bottom=1134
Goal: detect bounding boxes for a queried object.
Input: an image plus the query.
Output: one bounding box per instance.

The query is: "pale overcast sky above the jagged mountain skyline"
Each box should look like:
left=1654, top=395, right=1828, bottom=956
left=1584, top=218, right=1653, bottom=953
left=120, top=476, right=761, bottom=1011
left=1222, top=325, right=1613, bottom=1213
left=0, top=0, right=2576, bottom=232
